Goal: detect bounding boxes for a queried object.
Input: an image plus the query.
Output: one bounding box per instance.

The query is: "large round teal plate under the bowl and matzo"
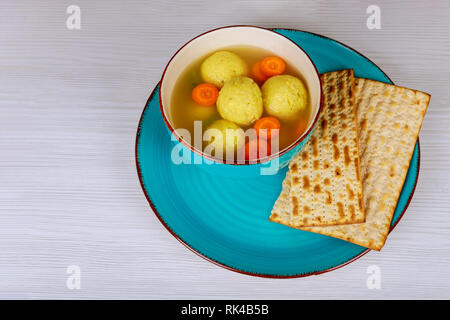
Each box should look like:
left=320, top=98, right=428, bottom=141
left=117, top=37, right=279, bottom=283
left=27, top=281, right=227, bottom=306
left=136, top=29, right=420, bottom=278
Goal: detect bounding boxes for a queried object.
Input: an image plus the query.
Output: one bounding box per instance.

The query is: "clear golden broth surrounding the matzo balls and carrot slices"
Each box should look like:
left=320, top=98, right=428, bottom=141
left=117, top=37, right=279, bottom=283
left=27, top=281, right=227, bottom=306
left=170, top=46, right=311, bottom=159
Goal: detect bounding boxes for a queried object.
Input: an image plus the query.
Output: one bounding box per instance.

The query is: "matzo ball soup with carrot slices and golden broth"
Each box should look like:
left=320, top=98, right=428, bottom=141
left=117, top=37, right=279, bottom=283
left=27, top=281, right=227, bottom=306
left=170, top=46, right=312, bottom=160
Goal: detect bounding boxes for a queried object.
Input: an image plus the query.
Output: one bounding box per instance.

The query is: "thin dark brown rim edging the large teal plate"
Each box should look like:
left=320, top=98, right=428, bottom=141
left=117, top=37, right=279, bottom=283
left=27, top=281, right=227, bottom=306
left=134, top=25, right=420, bottom=279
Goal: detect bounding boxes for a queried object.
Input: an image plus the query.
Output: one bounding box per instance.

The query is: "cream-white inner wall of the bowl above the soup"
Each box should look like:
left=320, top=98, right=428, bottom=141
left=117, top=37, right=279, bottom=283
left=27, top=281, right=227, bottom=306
left=159, top=26, right=322, bottom=175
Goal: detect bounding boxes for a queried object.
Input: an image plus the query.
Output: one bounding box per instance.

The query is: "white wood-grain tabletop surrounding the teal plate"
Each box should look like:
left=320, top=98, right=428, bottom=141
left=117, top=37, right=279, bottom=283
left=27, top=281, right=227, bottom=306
left=0, top=0, right=450, bottom=299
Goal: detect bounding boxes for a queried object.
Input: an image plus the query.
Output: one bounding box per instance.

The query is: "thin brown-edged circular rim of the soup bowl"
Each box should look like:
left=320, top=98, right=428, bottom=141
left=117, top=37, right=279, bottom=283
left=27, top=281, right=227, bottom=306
left=158, top=25, right=323, bottom=166
